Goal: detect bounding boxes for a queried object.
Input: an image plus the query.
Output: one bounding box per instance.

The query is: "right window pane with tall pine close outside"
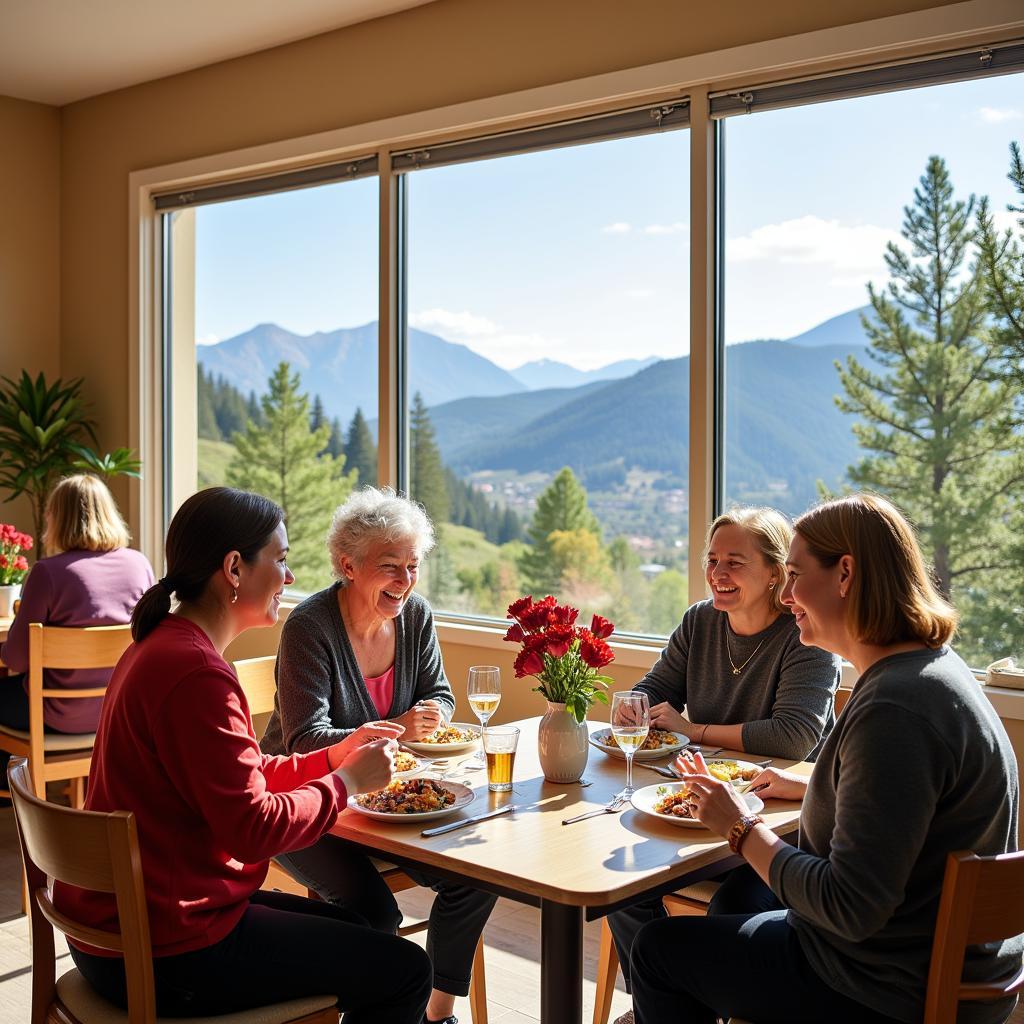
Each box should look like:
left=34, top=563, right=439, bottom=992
left=719, top=75, right=1024, bottom=665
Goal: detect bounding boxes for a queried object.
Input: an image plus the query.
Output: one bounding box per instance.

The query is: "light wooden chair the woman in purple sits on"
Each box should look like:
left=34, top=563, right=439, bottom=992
left=0, top=623, right=131, bottom=807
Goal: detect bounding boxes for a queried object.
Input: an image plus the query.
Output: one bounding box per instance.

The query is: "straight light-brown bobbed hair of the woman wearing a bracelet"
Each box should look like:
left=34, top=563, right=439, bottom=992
left=795, top=494, right=957, bottom=647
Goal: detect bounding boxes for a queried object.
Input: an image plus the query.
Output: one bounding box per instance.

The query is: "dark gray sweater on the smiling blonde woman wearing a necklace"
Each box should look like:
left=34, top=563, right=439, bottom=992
left=636, top=600, right=841, bottom=761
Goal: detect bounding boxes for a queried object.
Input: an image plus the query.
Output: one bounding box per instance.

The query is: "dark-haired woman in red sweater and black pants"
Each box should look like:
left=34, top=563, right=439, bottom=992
left=55, top=487, right=431, bottom=1024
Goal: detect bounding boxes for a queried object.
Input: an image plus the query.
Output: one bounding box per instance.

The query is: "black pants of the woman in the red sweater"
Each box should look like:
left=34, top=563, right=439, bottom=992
left=71, top=892, right=430, bottom=1024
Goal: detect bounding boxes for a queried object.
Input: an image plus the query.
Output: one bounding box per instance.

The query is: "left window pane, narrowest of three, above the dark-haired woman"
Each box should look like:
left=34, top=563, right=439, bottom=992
left=165, top=176, right=378, bottom=592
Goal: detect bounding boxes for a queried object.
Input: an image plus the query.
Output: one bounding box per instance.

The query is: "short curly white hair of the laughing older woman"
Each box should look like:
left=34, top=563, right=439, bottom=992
left=327, top=487, right=434, bottom=586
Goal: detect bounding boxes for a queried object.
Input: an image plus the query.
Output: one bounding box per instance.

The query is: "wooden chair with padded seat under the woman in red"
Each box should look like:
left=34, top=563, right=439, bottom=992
left=10, top=759, right=338, bottom=1024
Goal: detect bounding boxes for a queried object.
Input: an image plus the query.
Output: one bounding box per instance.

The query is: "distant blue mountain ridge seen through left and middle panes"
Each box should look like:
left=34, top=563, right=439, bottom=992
left=197, top=323, right=525, bottom=425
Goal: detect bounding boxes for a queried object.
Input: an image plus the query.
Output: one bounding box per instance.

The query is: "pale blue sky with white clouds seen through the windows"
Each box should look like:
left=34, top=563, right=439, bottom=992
left=196, top=75, right=1024, bottom=368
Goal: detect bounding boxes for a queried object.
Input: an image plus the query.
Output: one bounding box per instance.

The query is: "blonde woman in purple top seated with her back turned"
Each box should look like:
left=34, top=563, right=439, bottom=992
left=0, top=473, right=155, bottom=732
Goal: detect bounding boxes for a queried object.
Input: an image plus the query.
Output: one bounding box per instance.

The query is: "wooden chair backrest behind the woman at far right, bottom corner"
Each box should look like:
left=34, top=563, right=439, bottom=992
left=925, top=852, right=1024, bottom=1024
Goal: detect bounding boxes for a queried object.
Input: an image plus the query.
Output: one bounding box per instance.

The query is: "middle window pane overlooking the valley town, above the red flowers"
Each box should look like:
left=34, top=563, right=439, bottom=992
left=403, top=119, right=689, bottom=633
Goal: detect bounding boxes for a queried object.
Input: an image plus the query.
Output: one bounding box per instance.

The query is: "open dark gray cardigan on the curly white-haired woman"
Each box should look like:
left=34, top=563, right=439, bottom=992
left=260, top=584, right=455, bottom=754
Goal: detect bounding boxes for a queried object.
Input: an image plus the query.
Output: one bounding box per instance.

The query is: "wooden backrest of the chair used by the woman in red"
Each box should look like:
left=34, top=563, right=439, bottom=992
left=8, top=758, right=156, bottom=1024
